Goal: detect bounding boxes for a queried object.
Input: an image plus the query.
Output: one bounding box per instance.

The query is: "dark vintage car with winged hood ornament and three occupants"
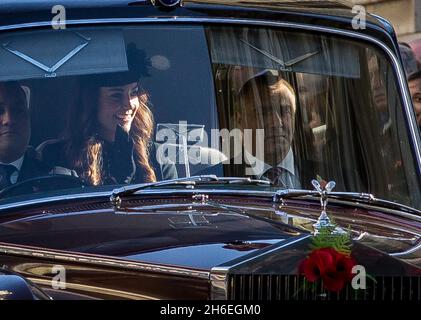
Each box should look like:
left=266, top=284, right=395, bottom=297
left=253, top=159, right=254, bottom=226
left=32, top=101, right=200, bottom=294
left=0, top=0, right=421, bottom=300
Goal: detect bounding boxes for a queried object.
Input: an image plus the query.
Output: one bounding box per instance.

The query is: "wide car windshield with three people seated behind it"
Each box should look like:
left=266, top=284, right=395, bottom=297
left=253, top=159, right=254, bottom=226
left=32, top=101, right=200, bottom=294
left=0, top=24, right=421, bottom=208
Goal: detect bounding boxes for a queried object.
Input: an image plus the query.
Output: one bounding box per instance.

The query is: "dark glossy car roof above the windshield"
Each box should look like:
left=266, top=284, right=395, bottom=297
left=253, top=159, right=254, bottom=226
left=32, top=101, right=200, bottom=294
left=0, top=0, right=397, bottom=52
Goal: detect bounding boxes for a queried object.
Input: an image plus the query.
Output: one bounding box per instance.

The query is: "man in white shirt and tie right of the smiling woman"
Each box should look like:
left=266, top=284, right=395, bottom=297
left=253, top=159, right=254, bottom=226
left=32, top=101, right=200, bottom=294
left=238, top=71, right=301, bottom=188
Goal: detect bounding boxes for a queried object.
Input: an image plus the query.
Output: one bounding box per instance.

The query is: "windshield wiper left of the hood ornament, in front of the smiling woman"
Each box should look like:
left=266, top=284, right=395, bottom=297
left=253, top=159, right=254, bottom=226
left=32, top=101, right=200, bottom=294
left=110, top=174, right=271, bottom=205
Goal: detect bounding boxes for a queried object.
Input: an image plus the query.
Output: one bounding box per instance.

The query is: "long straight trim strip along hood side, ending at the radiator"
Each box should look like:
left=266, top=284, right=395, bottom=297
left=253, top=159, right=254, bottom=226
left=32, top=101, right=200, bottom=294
left=0, top=242, right=210, bottom=280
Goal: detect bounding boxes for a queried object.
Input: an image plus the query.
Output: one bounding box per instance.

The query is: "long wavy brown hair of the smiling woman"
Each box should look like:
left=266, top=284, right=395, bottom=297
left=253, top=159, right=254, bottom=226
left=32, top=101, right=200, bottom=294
left=65, top=80, right=156, bottom=186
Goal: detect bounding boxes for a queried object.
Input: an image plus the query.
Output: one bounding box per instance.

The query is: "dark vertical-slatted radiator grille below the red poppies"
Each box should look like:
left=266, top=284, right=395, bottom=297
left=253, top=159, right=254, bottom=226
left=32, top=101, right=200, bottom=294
left=227, top=275, right=421, bottom=301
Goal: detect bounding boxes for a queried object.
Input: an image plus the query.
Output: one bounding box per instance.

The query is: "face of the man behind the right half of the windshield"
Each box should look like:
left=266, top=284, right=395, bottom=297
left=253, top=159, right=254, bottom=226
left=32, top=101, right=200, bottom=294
left=242, top=84, right=295, bottom=166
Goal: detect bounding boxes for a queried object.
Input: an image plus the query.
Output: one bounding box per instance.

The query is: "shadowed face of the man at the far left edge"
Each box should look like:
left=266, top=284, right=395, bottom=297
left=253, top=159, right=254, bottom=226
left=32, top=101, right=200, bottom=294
left=0, top=84, right=30, bottom=163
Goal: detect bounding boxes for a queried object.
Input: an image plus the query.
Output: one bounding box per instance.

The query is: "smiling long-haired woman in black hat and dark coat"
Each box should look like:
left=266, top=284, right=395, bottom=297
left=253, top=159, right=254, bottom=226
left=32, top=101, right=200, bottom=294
left=38, top=44, right=166, bottom=185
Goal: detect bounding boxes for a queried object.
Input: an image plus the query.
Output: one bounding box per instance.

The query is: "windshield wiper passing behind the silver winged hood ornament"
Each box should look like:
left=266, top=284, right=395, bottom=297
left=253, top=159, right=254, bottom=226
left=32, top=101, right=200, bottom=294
left=273, top=189, right=421, bottom=215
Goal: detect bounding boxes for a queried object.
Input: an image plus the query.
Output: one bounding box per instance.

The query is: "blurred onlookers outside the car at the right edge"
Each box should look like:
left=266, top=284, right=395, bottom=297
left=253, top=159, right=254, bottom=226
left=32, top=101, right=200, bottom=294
left=399, top=39, right=421, bottom=130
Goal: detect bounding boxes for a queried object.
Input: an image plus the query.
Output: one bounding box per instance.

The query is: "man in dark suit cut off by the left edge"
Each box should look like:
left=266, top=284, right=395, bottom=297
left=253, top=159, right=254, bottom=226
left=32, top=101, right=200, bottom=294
left=0, top=81, right=48, bottom=190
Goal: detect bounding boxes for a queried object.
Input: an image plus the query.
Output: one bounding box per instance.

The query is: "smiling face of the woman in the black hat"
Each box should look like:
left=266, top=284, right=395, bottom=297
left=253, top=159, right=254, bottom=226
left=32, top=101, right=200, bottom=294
left=98, top=82, right=141, bottom=141
